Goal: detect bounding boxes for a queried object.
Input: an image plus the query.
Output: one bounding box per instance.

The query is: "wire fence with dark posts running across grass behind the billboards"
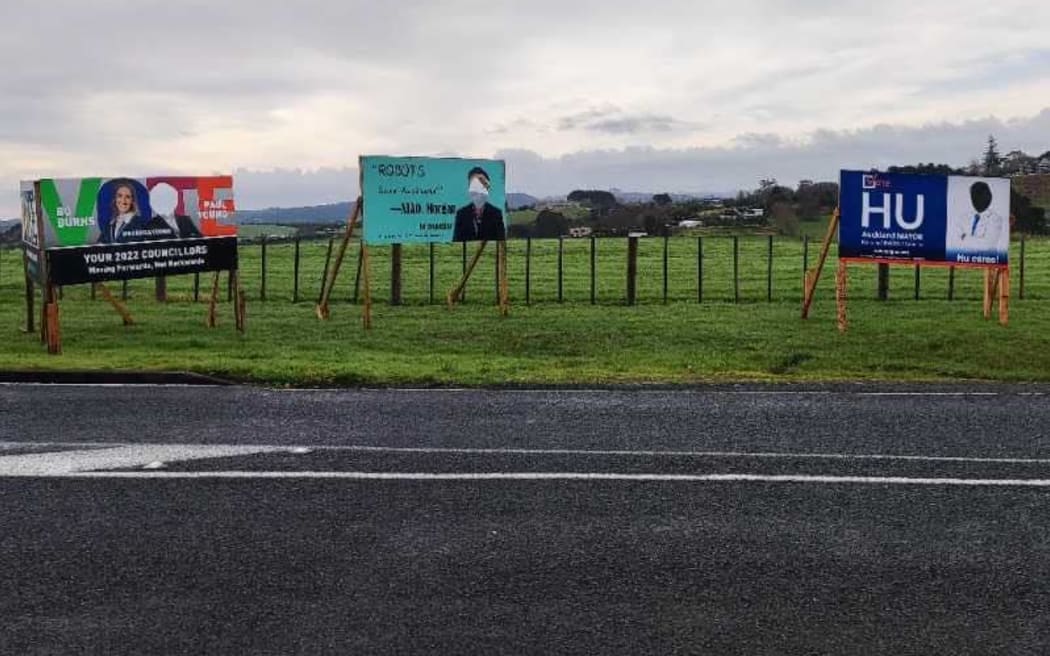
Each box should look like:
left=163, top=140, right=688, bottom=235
left=0, top=235, right=1050, bottom=305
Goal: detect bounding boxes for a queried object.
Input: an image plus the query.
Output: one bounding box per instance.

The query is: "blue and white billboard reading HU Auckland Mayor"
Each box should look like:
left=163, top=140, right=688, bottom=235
left=839, top=171, right=1010, bottom=266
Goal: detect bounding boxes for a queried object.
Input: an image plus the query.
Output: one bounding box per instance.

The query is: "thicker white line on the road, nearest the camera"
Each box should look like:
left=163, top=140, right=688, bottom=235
left=14, top=471, right=1050, bottom=488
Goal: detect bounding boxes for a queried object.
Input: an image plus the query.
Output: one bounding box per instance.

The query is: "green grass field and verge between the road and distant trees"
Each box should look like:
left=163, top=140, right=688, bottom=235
left=0, top=237, right=1050, bottom=385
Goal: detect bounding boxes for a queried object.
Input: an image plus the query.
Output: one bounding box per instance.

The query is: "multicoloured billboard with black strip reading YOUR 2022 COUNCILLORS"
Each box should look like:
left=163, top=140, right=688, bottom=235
left=20, top=175, right=237, bottom=284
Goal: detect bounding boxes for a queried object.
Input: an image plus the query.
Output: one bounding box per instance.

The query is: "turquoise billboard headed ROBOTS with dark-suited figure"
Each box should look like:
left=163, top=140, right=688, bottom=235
left=360, top=156, right=509, bottom=244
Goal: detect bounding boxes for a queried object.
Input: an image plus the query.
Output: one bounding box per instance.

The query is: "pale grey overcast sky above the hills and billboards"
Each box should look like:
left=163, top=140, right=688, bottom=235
left=0, top=0, right=1050, bottom=216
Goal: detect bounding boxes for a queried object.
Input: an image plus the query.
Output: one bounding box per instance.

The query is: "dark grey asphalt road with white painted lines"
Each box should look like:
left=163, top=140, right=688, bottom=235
left=0, top=385, right=1050, bottom=654
